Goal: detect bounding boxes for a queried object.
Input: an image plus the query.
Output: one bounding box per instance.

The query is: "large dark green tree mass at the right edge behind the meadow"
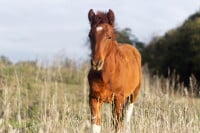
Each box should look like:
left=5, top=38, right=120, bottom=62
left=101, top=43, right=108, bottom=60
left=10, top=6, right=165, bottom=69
left=143, top=12, right=200, bottom=88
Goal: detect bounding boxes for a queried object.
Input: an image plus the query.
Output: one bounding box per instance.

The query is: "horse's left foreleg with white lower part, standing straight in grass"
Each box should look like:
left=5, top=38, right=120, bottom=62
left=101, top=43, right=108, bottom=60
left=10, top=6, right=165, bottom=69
left=89, top=98, right=102, bottom=133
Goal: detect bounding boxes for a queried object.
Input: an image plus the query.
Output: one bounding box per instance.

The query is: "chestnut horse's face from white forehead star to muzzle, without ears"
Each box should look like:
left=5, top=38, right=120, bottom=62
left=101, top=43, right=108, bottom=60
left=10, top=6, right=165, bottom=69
left=89, top=23, right=115, bottom=71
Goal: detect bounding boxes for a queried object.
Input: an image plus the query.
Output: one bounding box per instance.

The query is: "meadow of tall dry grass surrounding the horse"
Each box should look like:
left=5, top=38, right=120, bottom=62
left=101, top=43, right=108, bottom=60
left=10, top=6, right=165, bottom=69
left=0, top=62, right=200, bottom=133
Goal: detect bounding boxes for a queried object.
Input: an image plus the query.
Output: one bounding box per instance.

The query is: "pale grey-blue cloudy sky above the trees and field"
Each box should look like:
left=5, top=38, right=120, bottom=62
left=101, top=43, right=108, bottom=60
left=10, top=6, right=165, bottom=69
left=0, top=0, right=200, bottom=62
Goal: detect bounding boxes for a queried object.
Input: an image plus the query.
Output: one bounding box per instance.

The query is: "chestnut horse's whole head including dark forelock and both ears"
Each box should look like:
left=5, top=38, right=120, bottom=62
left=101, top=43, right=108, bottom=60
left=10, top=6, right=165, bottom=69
left=88, top=9, right=115, bottom=71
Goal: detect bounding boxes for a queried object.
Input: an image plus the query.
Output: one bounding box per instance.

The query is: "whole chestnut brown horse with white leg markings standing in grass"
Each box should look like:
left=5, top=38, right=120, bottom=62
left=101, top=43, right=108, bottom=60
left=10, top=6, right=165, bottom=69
left=88, top=10, right=142, bottom=133
